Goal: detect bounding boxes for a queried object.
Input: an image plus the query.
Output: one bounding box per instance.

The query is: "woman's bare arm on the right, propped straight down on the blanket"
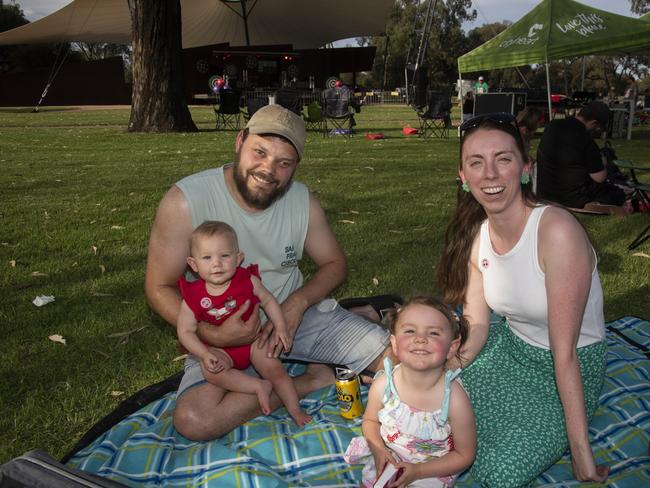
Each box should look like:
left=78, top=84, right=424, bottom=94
left=538, top=208, right=609, bottom=481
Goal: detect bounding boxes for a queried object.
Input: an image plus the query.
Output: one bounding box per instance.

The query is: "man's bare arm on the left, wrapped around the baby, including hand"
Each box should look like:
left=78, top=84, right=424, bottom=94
left=145, top=186, right=260, bottom=347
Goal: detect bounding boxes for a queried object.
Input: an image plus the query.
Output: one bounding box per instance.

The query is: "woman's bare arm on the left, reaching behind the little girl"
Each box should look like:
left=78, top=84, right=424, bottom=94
left=447, top=236, right=490, bottom=369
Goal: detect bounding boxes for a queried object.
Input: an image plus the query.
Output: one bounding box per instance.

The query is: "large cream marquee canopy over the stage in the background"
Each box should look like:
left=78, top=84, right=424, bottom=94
left=0, top=0, right=395, bottom=49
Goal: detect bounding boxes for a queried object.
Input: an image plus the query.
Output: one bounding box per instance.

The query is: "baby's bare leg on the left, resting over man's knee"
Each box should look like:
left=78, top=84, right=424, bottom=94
left=201, top=348, right=279, bottom=415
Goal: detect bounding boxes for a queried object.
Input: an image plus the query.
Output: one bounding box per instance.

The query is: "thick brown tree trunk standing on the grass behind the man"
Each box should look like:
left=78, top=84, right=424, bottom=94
left=129, top=0, right=197, bottom=132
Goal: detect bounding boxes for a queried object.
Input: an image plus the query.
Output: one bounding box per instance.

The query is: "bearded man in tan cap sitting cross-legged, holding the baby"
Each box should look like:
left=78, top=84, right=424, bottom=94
left=145, top=105, right=388, bottom=440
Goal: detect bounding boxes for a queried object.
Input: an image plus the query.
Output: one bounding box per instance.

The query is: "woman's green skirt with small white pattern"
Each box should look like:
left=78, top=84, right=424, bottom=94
left=461, top=320, right=607, bottom=487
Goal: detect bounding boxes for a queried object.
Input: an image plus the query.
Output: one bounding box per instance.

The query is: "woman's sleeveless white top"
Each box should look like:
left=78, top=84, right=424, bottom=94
left=477, top=206, right=605, bottom=349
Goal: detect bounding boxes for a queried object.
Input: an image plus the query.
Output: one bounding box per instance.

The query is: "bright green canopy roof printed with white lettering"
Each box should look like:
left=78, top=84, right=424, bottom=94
left=458, top=0, right=650, bottom=73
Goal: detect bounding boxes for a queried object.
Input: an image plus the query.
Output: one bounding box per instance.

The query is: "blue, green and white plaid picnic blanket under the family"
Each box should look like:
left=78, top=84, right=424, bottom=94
left=68, top=317, right=650, bottom=488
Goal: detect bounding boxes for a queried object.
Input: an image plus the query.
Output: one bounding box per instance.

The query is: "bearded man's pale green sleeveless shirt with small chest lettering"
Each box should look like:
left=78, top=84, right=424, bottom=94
left=176, top=167, right=309, bottom=303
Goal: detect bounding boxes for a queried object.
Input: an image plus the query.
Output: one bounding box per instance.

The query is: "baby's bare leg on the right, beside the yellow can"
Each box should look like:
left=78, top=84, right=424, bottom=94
left=251, top=344, right=311, bottom=427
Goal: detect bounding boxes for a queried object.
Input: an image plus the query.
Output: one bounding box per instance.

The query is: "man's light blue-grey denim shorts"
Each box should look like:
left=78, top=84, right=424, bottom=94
left=178, top=298, right=390, bottom=396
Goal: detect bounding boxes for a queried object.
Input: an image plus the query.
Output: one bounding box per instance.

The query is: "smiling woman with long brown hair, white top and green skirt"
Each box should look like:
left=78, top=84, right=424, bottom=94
left=438, top=114, right=609, bottom=487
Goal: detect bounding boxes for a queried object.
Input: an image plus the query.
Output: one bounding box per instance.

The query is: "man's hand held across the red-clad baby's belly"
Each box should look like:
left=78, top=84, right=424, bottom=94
left=197, top=300, right=261, bottom=347
